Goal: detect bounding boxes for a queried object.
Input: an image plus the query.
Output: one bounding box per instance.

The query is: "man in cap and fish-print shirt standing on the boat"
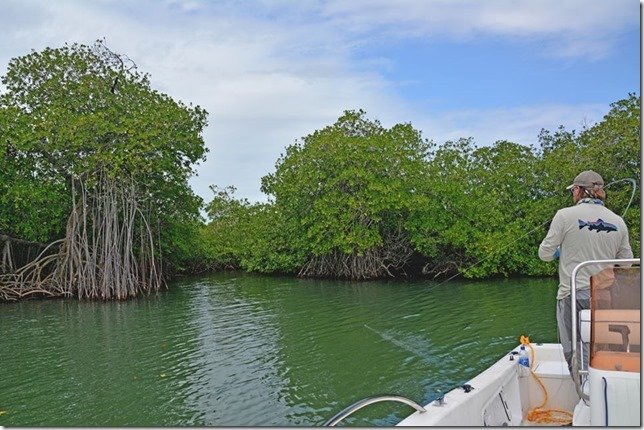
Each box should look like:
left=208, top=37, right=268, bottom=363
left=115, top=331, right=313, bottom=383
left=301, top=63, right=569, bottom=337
left=539, top=170, right=633, bottom=371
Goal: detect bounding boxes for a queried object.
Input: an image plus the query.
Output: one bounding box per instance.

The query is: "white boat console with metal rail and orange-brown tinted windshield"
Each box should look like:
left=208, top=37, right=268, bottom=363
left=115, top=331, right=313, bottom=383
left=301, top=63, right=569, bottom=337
left=572, top=259, right=641, bottom=426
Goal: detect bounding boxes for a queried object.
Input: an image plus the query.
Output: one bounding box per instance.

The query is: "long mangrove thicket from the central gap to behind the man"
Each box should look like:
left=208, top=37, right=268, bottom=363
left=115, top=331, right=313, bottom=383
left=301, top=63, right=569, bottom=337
left=208, top=94, right=640, bottom=278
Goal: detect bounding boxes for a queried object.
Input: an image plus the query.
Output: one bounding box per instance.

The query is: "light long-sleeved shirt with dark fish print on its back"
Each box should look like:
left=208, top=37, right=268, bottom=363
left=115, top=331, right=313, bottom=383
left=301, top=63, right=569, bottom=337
left=539, top=199, right=633, bottom=299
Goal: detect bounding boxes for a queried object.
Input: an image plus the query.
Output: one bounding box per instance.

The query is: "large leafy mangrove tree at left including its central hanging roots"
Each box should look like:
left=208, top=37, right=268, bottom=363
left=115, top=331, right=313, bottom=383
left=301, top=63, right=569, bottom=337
left=0, top=41, right=207, bottom=298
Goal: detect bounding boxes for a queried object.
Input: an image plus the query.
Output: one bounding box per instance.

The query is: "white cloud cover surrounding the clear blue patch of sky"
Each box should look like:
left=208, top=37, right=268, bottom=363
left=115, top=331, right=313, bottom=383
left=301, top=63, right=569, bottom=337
left=0, top=0, right=639, bottom=205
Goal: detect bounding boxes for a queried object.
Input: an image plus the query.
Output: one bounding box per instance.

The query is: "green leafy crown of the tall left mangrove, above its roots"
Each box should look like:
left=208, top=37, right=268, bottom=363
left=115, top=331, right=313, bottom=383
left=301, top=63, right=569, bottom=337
left=0, top=41, right=207, bottom=276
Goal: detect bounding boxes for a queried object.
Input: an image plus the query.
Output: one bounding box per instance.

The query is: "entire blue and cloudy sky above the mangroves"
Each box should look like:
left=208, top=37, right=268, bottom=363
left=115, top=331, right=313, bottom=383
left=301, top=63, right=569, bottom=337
left=0, top=0, right=642, bottom=202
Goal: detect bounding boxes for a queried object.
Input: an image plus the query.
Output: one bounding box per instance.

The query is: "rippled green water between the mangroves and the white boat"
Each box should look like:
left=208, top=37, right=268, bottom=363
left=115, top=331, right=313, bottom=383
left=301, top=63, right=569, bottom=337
left=0, top=274, right=557, bottom=427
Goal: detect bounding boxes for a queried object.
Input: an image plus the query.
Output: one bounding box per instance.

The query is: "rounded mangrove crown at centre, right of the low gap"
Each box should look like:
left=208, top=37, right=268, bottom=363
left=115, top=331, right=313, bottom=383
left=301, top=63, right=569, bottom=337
left=262, top=111, right=429, bottom=278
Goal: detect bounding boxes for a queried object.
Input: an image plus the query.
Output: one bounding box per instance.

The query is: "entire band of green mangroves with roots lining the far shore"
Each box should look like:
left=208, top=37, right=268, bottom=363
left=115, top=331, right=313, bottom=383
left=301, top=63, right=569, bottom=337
left=0, top=40, right=641, bottom=301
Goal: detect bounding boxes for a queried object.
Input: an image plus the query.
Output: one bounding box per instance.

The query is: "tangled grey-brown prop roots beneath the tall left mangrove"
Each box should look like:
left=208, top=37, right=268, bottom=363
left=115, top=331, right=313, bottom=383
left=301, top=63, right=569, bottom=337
left=0, top=170, right=163, bottom=301
